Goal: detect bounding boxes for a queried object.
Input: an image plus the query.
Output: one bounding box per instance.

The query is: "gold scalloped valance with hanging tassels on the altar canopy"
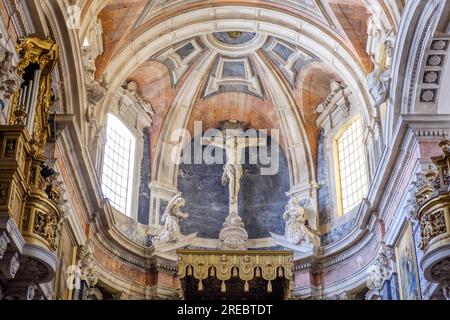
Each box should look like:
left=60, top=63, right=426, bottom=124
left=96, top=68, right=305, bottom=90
left=178, top=250, right=293, bottom=293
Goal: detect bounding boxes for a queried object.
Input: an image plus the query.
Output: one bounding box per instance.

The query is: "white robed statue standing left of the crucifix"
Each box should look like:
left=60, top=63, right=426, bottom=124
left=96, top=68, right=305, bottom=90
left=153, top=195, right=189, bottom=244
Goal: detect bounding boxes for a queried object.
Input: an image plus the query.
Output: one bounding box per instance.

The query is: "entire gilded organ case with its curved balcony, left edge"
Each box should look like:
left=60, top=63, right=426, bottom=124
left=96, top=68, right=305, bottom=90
left=0, top=38, right=61, bottom=251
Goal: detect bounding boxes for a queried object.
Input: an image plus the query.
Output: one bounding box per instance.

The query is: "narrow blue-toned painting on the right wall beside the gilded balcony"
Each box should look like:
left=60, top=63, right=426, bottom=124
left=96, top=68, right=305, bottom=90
left=395, top=223, right=421, bottom=300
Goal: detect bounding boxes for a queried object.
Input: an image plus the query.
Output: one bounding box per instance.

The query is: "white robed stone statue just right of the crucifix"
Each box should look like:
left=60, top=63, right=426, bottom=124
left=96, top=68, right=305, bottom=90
left=283, top=198, right=316, bottom=244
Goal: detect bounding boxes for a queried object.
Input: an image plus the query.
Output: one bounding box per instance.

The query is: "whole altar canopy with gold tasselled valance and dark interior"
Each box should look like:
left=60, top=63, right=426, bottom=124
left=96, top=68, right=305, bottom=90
left=177, top=250, right=294, bottom=300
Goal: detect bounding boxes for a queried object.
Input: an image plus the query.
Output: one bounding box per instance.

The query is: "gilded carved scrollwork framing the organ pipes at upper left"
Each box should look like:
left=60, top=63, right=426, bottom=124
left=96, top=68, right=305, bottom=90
left=10, top=38, right=59, bottom=156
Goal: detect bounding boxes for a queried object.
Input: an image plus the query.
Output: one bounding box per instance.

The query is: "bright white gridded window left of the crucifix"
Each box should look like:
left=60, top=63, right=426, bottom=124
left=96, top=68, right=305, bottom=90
left=102, top=114, right=136, bottom=215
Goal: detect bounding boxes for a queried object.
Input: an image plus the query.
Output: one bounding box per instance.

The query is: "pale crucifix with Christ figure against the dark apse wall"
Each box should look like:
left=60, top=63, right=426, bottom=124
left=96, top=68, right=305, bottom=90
left=202, top=121, right=266, bottom=249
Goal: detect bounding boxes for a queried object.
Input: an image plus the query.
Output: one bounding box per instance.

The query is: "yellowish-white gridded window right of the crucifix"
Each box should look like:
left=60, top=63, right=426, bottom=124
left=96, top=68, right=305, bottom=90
left=335, top=118, right=368, bottom=215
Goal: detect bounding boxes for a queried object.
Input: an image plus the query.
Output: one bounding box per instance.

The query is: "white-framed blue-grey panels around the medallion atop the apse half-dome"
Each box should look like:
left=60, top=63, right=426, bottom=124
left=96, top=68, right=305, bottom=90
left=150, top=31, right=317, bottom=100
